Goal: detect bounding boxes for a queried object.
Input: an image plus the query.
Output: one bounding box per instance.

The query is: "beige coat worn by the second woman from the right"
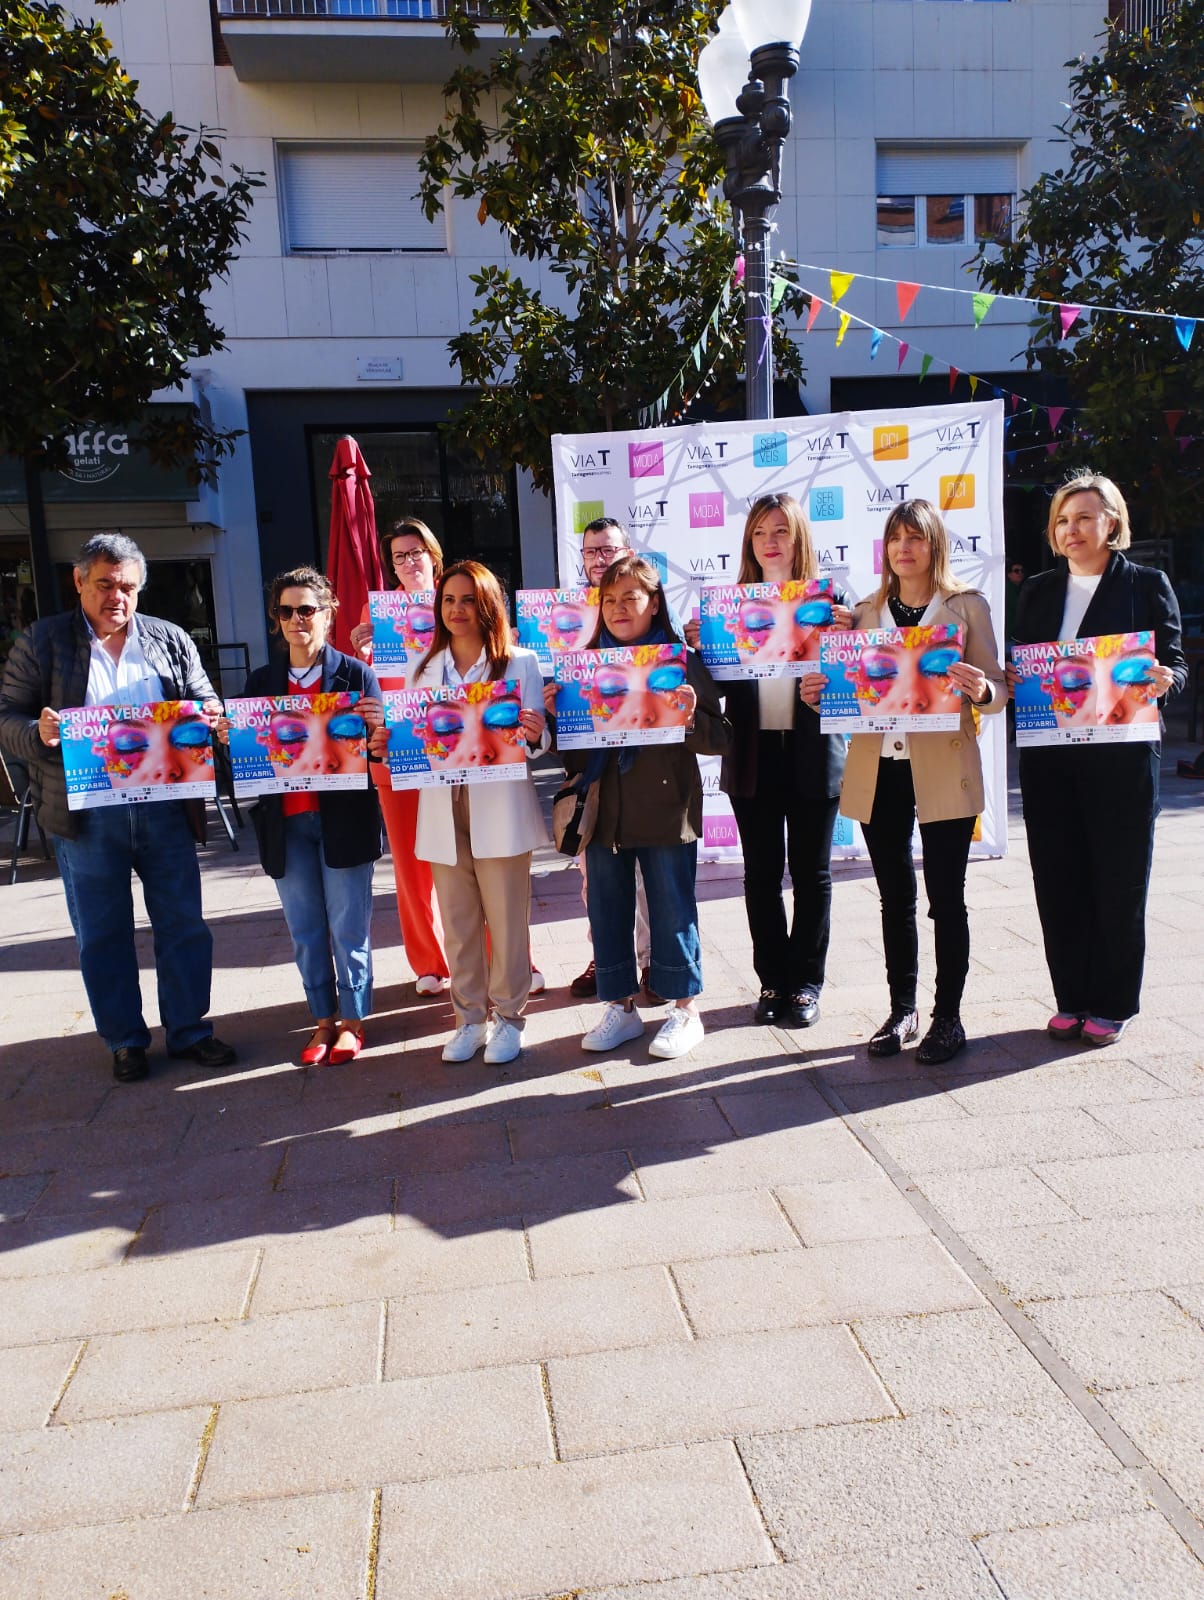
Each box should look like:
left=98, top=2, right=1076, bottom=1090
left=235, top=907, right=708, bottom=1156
left=841, top=590, right=1007, bottom=822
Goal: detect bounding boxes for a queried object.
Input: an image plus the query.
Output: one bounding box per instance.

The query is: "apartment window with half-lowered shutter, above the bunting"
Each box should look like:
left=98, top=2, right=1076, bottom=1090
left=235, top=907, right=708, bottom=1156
left=877, top=144, right=1020, bottom=250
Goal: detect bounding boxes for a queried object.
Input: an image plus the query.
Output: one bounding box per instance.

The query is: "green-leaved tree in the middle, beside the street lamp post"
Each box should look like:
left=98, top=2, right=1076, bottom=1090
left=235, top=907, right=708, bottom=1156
left=421, top=0, right=802, bottom=491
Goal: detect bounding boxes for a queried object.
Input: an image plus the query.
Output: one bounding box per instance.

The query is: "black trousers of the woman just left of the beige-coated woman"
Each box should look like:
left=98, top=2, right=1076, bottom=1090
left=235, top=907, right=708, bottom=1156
left=732, top=730, right=837, bottom=994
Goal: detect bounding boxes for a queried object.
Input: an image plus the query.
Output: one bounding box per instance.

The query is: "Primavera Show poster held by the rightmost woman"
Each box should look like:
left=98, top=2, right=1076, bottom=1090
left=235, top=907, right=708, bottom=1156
left=1012, top=629, right=1159, bottom=747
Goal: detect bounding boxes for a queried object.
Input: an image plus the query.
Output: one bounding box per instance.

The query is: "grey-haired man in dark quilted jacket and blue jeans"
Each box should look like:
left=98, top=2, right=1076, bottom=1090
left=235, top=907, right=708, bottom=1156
left=0, top=533, right=235, bottom=1083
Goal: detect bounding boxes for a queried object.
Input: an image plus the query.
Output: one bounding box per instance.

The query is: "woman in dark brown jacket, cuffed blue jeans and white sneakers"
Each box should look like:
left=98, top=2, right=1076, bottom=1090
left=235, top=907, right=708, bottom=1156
left=565, top=555, right=732, bottom=1059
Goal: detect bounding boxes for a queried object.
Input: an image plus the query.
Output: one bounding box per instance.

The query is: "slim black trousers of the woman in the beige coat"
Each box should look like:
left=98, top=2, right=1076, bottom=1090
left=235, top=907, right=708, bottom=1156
left=861, top=760, right=973, bottom=1016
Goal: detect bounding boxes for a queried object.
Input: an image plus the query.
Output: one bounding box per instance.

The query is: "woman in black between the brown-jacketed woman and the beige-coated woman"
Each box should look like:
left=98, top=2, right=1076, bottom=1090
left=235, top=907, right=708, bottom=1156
left=719, top=494, right=852, bottom=1027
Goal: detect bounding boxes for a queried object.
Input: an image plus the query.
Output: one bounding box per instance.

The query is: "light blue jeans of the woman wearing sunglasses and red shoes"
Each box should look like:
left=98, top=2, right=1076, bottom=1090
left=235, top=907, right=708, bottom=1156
left=275, top=811, right=371, bottom=1021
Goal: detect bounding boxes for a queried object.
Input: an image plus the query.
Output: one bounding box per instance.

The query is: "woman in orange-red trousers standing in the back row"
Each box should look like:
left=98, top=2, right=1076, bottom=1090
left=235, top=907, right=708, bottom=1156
left=351, top=517, right=450, bottom=995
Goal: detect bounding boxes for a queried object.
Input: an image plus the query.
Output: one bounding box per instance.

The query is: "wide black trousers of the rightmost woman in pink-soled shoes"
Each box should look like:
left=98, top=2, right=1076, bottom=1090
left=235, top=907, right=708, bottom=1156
left=1020, top=744, right=1161, bottom=1021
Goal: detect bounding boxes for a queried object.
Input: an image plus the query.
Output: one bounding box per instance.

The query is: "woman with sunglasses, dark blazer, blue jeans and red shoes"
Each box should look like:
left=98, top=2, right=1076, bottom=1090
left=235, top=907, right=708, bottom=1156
left=236, top=566, right=384, bottom=1067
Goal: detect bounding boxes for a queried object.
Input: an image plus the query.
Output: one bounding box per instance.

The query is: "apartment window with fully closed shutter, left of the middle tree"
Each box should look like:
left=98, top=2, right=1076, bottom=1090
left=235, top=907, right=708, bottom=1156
left=277, top=142, right=447, bottom=256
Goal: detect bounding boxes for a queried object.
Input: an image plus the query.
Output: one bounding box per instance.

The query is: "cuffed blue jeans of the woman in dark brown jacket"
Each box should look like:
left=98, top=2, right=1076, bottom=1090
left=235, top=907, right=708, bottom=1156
left=586, top=843, right=703, bottom=1000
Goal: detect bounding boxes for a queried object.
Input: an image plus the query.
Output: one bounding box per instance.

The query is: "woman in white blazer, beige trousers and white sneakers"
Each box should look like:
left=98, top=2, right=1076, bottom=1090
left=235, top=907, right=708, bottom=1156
left=410, top=562, right=549, bottom=1066
